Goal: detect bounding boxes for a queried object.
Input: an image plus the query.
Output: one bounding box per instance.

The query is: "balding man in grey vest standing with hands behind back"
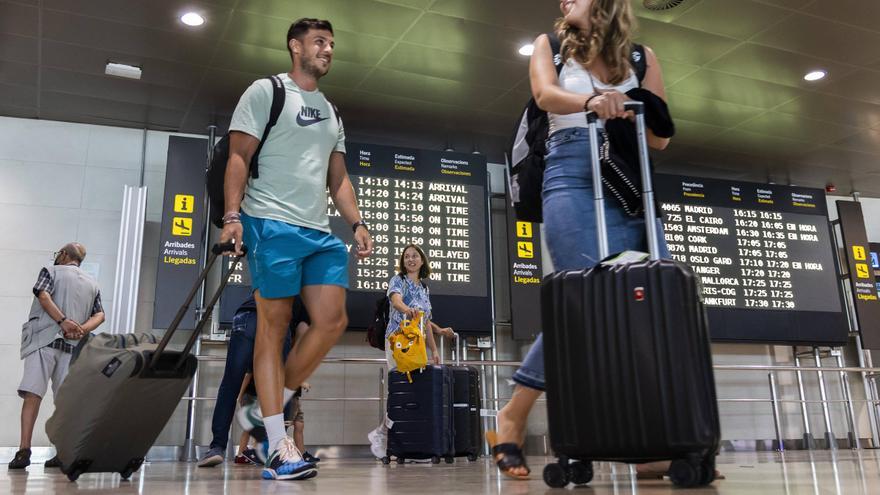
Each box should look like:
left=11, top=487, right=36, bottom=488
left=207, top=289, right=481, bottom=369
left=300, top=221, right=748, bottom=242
left=9, top=242, right=104, bottom=469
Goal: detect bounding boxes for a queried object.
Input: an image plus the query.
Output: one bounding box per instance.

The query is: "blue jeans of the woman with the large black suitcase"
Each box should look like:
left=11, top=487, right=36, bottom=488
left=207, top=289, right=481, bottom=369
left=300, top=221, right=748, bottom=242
left=513, top=127, right=669, bottom=390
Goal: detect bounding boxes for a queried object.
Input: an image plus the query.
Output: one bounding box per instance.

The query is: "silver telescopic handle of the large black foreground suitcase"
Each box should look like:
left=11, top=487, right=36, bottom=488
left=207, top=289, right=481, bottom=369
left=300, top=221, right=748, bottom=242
left=587, top=101, right=660, bottom=260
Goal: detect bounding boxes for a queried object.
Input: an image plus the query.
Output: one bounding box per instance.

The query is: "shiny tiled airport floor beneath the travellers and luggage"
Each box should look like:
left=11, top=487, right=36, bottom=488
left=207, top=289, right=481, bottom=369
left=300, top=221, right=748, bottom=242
left=0, top=450, right=880, bottom=495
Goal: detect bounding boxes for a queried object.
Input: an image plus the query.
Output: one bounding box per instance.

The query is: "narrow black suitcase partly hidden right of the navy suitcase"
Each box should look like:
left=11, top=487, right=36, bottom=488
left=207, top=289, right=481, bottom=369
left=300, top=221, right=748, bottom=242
left=452, top=366, right=482, bottom=461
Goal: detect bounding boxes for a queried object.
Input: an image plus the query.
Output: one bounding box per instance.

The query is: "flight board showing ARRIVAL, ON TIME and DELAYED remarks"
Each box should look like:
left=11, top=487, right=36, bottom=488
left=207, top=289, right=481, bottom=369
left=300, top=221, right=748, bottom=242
left=328, top=143, right=492, bottom=333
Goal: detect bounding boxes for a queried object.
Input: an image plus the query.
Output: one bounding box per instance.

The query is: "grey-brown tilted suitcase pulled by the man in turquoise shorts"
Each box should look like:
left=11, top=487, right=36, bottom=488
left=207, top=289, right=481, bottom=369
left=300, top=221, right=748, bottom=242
left=46, top=245, right=248, bottom=481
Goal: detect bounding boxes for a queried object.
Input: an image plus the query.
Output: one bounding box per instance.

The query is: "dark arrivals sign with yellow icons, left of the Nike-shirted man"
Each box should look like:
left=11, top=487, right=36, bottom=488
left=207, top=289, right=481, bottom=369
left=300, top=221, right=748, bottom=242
left=153, top=136, right=207, bottom=330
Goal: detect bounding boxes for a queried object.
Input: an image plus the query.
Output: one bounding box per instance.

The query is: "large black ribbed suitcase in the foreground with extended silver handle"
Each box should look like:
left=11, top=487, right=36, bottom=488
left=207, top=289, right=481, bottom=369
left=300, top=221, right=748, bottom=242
left=541, top=104, right=720, bottom=487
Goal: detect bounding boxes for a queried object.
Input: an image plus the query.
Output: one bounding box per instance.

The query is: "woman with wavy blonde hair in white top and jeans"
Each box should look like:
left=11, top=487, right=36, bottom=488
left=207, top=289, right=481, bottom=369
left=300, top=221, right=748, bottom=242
left=489, top=0, right=669, bottom=479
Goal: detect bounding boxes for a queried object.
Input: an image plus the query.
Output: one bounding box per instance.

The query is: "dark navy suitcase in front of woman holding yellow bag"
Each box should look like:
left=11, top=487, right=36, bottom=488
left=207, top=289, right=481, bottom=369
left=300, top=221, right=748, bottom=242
left=382, top=365, right=454, bottom=464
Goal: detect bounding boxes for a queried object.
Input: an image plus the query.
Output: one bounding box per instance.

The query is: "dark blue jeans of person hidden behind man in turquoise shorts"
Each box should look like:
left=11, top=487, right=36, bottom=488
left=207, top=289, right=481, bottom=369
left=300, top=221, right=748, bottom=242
left=211, top=311, right=291, bottom=450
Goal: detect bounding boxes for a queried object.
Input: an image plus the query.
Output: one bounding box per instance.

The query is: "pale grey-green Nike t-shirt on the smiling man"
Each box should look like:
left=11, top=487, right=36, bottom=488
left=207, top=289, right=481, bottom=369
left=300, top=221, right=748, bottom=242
left=229, top=74, right=345, bottom=232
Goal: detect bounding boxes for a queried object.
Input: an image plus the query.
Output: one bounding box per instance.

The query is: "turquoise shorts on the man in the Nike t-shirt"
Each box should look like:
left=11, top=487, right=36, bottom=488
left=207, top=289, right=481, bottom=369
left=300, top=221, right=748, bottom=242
left=241, top=213, right=348, bottom=299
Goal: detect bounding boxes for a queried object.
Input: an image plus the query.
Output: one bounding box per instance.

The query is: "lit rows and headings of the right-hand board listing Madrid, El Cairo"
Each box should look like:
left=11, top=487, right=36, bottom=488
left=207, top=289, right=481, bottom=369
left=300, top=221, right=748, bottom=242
left=659, top=176, right=840, bottom=312
